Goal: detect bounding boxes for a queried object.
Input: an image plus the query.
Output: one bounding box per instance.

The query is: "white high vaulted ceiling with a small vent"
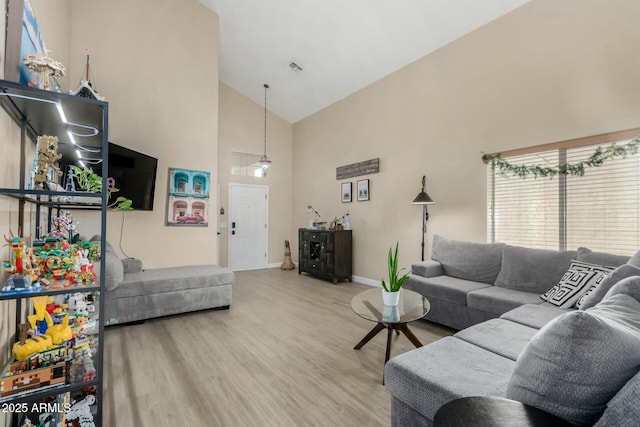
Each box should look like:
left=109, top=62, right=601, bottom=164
left=200, top=0, right=529, bottom=123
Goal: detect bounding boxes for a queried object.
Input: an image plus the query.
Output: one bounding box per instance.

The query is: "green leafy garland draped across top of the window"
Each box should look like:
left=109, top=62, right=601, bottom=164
left=482, top=137, right=640, bottom=179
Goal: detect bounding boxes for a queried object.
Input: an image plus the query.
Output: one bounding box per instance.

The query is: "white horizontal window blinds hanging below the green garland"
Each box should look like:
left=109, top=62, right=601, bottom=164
left=487, top=140, right=640, bottom=255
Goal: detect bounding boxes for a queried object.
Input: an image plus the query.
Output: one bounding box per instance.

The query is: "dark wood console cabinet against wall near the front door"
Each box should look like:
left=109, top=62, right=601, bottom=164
left=298, top=228, right=351, bottom=284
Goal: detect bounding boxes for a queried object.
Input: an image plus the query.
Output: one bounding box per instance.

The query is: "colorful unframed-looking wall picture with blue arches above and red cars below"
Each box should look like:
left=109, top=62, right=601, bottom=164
left=167, top=168, right=211, bottom=227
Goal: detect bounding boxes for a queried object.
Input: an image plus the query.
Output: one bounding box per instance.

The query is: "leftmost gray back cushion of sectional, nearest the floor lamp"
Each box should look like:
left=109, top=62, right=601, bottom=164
left=431, top=234, right=504, bottom=284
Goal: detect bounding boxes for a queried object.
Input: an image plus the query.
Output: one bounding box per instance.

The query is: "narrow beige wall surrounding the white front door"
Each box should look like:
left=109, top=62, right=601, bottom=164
left=218, top=82, right=297, bottom=266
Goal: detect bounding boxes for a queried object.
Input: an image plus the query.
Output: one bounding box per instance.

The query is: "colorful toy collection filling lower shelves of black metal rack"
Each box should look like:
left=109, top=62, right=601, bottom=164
left=0, top=212, right=100, bottom=426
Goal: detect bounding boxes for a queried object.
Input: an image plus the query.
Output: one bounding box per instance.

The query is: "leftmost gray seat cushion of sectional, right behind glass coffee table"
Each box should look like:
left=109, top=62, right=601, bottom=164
left=404, top=275, right=493, bottom=306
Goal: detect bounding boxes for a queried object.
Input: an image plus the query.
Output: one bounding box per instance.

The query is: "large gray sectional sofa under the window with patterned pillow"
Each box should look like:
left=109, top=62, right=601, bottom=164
left=385, top=237, right=640, bottom=427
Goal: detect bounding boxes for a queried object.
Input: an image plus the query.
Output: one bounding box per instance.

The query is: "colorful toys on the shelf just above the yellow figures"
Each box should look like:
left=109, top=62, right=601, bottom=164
left=0, top=213, right=100, bottom=295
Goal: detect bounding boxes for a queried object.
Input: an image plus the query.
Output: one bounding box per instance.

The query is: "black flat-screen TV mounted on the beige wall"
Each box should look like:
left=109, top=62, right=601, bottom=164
left=95, top=142, right=158, bottom=211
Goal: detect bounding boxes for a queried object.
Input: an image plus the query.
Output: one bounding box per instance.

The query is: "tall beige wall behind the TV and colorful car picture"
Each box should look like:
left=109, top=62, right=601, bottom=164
left=64, top=0, right=218, bottom=268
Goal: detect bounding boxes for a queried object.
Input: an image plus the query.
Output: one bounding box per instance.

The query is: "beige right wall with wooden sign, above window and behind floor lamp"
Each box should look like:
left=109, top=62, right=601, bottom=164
left=292, top=0, right=640, bottom=281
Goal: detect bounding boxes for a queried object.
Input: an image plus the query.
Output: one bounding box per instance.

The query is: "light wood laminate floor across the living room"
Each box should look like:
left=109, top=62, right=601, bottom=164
left=103, top=269, right=453, bottom=427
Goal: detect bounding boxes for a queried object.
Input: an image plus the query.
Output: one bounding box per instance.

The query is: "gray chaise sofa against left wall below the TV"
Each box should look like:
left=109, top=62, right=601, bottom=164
left=92, top=236, right=235, bottom=325
